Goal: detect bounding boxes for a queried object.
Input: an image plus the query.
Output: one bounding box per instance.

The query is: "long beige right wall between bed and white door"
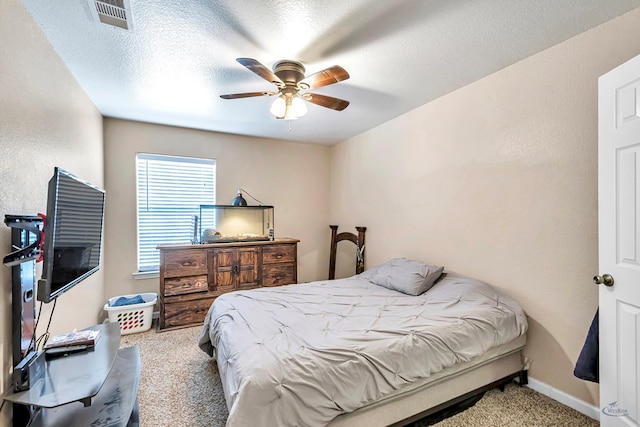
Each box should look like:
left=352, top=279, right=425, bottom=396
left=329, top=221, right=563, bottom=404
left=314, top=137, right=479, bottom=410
left=331, top=10, right=640, bottom=405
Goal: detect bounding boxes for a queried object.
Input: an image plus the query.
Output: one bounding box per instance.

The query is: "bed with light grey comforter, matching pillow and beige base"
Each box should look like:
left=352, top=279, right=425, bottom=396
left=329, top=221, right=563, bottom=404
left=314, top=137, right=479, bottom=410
left=199, top=258, right=527, bottom=427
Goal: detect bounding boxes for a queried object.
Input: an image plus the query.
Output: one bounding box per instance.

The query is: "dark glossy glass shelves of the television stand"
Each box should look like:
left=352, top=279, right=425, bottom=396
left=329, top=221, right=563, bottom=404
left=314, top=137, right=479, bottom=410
left=3, top=322, right=140, bottom=427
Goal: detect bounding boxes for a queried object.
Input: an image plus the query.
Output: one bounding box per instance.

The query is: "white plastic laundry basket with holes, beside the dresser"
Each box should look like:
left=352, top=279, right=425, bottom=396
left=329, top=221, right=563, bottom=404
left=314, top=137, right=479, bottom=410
left=104, top=292, right=158, bottom=335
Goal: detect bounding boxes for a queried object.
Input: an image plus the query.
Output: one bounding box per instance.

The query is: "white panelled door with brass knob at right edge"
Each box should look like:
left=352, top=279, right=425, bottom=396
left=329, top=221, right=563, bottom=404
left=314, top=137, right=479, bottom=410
left=598, top=56, right=640, bottom=427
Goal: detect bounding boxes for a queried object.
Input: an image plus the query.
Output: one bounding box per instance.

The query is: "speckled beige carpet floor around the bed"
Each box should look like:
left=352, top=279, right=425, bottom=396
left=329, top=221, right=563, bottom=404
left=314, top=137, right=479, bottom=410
left=122, top=327, right=599, bottom=427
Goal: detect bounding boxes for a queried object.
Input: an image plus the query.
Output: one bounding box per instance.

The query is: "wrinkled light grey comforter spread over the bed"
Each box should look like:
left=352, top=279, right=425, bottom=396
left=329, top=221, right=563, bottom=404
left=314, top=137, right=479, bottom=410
left=199, top=272, right=527, bottom=427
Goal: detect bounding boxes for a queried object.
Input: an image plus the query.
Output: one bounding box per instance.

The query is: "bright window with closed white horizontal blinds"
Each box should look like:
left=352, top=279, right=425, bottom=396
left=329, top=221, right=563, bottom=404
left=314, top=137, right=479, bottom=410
left=136, top=153, right=216, bottom=272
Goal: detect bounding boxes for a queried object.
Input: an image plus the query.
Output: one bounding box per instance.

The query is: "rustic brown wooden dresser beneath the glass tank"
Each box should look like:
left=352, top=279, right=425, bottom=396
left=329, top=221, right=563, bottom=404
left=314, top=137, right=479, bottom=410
left=158, top=239, right=299, bottom=330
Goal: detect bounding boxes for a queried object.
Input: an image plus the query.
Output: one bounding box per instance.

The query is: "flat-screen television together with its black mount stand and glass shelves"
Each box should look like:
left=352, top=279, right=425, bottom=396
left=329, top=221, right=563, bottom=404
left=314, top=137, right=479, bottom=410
left=2, top=168, right=140, bottom=427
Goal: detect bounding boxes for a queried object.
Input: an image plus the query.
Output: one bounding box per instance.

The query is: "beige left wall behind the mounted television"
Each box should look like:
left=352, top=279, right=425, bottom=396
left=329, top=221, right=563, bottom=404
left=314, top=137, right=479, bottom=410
left=0, top=0, right=104, bottom=425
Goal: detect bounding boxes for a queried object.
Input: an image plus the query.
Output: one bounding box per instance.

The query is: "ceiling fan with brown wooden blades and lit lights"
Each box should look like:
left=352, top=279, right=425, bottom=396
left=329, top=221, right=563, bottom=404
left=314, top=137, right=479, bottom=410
left=220, top=58, right=349, bottom=120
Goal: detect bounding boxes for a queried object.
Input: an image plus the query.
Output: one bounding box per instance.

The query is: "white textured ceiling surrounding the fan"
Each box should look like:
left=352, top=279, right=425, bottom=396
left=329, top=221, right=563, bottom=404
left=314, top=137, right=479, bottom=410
left=17, top=0, right=640, bottom=144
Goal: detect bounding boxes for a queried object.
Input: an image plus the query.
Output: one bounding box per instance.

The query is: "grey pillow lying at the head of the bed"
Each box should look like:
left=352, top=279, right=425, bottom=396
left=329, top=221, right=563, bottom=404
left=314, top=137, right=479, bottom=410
left=360, top=258, right=444, bottom=295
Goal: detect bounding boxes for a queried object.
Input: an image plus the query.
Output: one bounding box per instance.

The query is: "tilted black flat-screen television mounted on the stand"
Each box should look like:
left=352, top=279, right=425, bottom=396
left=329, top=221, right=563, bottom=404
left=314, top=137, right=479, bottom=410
left=37, top=167, right=105, bottom=303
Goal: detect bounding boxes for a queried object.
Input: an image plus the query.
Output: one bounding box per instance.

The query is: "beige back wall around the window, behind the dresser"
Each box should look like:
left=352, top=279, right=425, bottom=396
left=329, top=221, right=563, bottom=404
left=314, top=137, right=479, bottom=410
left=104, top=118, right=330, bottom=297
